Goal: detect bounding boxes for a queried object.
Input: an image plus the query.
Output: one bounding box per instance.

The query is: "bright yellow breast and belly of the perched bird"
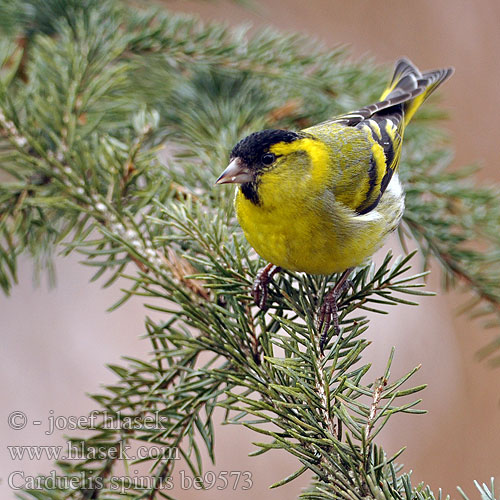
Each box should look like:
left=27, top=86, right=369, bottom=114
left=235, top=176, right=390, bottom=274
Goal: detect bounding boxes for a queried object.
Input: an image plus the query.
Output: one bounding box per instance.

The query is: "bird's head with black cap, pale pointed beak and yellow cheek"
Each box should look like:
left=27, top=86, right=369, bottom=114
left=216, top=129, right=317, bottom=204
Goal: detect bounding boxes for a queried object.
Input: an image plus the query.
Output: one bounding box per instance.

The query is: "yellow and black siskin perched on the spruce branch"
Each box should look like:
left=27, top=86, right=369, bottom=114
left=216, top=57, right=454, bottom=352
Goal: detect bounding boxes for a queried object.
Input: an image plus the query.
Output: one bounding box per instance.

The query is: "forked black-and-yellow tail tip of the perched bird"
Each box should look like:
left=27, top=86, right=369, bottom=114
left=380, top=57, right=454, bottom=126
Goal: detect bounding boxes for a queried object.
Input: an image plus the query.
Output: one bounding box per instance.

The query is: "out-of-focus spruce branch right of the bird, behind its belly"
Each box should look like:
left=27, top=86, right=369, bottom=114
left=400, top=146, right=500, bottom=365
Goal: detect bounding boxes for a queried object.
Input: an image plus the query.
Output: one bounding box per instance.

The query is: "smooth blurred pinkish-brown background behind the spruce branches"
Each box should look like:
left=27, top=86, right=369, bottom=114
left=0, top=0, right=500, bottom=500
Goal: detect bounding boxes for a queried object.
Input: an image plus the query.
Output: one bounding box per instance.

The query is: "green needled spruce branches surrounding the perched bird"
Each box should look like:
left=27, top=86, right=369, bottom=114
left=0, top=0, right=500, bottom=500
